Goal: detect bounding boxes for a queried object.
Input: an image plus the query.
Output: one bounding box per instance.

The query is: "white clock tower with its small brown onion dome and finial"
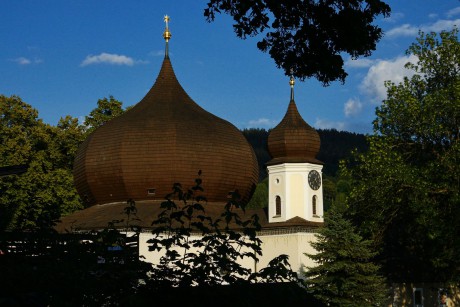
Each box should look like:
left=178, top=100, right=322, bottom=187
left=267, top=76, right=323, bottom=223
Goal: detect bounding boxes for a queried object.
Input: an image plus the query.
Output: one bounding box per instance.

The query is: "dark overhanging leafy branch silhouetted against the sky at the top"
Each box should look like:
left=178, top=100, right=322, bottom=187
left=204, top=0, right=390, bottom=85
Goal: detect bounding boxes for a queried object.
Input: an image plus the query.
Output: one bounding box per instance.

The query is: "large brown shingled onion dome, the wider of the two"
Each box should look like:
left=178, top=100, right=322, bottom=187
left=74, top=54, right=258, bottom=205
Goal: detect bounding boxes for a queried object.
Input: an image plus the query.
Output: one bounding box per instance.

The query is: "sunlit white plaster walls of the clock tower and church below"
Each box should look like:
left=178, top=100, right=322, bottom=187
left=135, top=163, right=323, bottom=276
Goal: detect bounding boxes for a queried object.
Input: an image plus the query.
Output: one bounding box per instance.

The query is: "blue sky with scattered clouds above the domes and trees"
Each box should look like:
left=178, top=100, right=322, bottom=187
left=0, top=0, right=460, bottom=133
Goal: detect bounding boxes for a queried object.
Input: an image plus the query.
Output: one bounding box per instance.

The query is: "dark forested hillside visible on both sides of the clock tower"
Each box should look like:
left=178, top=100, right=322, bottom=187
left=242, top=128, right=368, bottom=181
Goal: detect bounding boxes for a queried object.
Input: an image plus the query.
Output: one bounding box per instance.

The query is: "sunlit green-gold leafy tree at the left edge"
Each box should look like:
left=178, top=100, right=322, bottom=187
left=0, top=95, right=82, bottom=230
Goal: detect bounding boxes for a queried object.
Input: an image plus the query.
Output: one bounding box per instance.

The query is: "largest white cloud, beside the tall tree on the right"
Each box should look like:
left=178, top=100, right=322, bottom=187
left=360, top=55, right=418, bottom=104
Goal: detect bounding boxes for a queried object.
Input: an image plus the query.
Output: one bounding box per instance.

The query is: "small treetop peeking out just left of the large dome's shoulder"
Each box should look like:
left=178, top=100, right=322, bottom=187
left=84, top=96, right=124, bottom=134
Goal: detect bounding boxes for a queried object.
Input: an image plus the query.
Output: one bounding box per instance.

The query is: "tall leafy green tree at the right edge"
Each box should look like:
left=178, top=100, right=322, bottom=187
left=344, top=29, right=460, bottom=281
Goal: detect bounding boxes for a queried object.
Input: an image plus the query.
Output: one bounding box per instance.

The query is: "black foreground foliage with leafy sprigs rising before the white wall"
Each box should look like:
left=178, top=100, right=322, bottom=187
left=0, top=179, right=320, bottom=306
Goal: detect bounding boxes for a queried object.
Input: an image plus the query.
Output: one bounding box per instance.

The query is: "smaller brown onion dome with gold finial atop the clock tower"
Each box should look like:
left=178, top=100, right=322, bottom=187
left=268, top=78, right=321, bottom=164
